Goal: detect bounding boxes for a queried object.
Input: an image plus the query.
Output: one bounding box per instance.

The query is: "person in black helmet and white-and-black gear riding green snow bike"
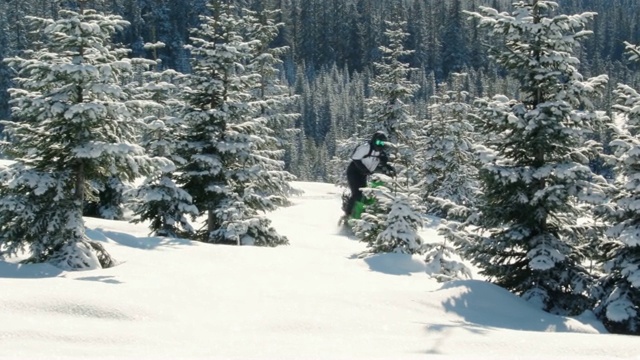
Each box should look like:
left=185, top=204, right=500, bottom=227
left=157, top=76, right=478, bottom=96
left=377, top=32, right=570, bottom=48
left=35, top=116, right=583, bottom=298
left=342, top=131, right=396, bottom=216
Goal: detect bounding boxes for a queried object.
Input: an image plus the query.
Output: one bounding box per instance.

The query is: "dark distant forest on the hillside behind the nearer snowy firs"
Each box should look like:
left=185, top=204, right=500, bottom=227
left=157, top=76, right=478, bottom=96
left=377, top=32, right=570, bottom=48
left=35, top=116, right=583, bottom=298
left=0, top=0, right=640, bottom=181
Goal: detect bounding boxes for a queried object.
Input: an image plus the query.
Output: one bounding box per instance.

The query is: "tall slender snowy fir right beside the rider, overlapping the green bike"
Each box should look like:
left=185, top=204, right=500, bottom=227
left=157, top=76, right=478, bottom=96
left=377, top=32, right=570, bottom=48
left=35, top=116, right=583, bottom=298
left=350, top=16, right=422, bottom=253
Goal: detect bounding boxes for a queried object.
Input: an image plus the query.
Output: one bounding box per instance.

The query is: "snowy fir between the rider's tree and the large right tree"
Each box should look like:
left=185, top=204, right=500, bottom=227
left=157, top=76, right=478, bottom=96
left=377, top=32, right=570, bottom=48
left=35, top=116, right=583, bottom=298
left=419, top=73, right=479, bottom=219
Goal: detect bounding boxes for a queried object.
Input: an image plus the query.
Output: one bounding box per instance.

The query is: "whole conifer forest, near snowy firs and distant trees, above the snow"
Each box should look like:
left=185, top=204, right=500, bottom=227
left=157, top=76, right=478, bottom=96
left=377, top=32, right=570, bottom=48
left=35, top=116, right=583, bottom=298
left=0, top=0, right=640, bottom=335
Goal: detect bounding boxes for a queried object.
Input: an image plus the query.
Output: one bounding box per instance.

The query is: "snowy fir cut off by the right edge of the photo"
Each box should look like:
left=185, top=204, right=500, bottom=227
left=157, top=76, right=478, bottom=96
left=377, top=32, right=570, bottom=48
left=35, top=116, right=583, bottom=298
left=594, top=43, right=640, bottom=335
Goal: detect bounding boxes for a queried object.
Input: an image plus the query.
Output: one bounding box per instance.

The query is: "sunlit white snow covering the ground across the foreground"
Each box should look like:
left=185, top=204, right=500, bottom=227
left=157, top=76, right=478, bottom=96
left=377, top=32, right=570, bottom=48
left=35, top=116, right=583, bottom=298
left=0, top=182, right=640, bottom=360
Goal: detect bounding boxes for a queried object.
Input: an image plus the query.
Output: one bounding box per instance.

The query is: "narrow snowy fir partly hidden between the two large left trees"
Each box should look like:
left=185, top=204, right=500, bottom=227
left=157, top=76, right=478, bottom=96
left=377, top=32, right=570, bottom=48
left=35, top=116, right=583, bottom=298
left=126, top=49, right=198, bottom=237
